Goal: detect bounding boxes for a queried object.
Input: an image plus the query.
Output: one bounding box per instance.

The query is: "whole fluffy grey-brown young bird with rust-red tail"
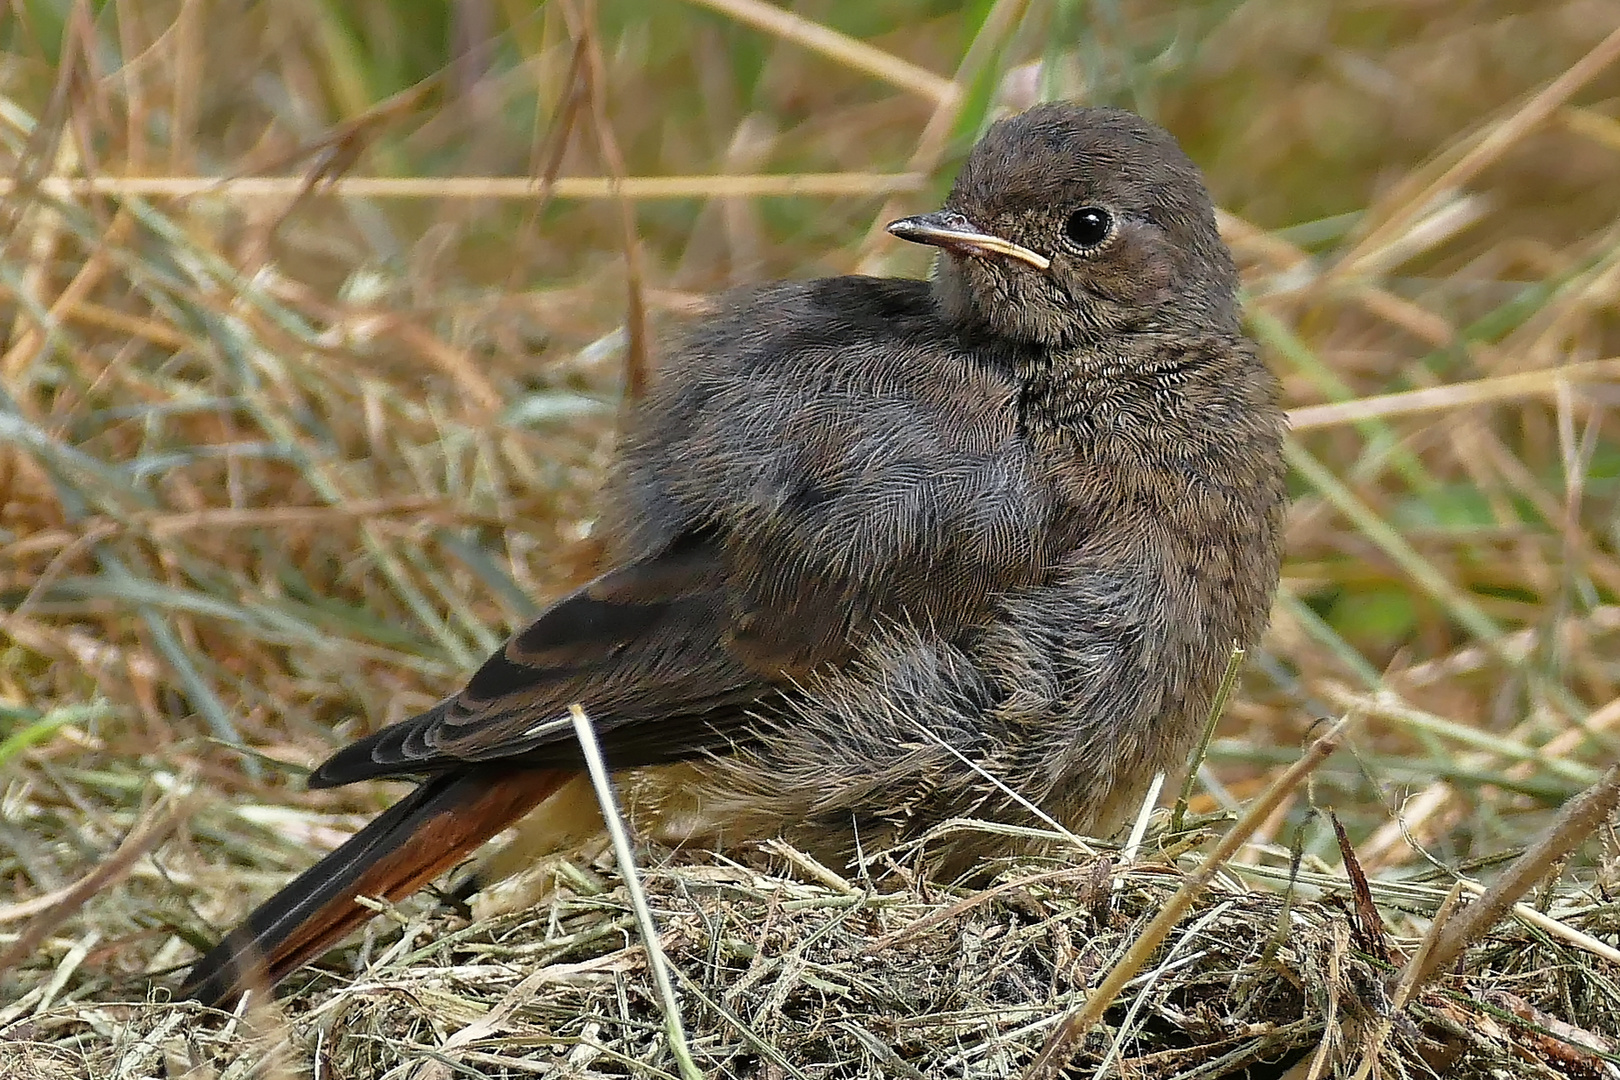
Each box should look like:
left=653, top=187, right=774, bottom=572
left=181, top=102, right=1286, bottom=1004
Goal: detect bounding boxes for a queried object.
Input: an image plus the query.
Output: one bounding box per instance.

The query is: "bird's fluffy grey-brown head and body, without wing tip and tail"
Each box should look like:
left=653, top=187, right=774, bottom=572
left=619, top=105, right=1285, bottom=868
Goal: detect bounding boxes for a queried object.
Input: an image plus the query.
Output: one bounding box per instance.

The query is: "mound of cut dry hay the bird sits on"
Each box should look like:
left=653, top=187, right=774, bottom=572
left=0, top=826, right=1620, bottom=1080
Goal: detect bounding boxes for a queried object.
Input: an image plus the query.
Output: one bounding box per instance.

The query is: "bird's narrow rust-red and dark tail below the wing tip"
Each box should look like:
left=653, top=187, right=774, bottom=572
left=180, top=769, right=572, bottom=1006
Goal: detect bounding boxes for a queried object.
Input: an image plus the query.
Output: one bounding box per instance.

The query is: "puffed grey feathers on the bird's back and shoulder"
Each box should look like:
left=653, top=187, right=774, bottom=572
left=619, top=279, right=1047, bottom=592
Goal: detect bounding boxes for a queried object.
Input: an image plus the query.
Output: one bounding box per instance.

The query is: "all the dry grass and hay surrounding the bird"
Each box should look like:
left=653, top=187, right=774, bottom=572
left=0, top=0, right=1620, bottom=1078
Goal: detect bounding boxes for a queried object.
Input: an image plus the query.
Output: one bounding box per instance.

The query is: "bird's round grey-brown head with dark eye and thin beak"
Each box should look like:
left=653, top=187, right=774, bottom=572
left=888, top=102, right=1238, bottom=347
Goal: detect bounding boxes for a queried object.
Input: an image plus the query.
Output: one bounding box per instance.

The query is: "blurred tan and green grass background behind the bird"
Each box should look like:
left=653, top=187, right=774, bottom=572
left=0, top=0, right=1620, bottom=1009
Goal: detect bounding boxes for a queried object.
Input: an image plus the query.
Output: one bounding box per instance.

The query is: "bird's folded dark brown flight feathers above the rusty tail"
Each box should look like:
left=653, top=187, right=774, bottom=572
left=309, top=536, right=786, bottom=787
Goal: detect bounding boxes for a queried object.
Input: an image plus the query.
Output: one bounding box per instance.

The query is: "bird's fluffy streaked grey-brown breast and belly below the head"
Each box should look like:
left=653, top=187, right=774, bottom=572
left=708, top=338, right=1285, bottom=871
